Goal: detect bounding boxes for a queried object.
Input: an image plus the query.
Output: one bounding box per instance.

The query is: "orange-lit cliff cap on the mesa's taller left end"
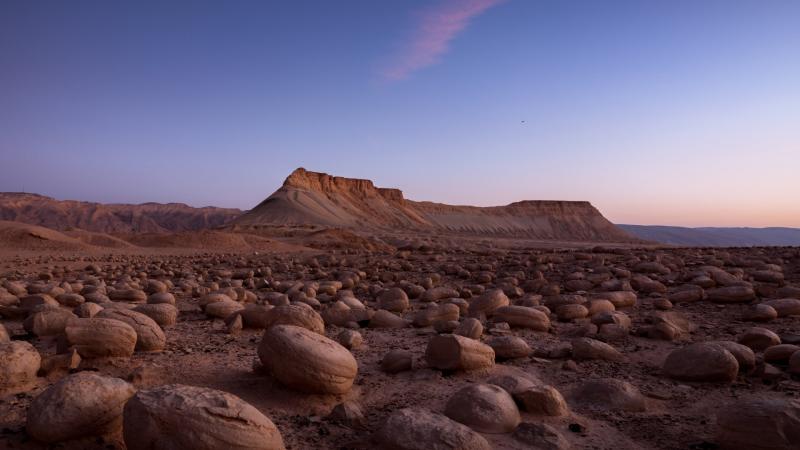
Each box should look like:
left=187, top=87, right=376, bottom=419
left=283, top=167, right=403, bottom=202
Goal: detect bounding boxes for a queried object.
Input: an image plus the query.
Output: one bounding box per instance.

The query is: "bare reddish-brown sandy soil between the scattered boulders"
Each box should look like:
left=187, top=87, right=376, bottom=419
left=0, top=235, right=800, bottom=449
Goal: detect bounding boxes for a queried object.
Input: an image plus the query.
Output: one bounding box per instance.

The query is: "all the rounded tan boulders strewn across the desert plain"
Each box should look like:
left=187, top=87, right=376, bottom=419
left=0, top=244, right=800, bottom=449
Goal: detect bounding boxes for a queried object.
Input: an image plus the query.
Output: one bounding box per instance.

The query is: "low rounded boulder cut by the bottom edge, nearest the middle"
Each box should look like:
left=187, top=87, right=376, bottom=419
left=376, top=408, right=492, bottom=450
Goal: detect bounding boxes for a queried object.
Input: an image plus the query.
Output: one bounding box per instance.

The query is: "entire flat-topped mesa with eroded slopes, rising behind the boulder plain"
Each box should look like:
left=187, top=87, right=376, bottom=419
left=234, top=168, right=636, bottom=242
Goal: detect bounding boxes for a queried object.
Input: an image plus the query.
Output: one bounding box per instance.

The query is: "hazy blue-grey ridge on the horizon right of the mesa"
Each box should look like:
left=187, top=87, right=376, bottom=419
left=618, top=224, right=800, bottom=247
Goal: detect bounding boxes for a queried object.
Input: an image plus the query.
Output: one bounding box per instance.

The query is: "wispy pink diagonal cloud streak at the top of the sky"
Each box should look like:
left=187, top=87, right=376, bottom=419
left=381, top=0, right=505, bottom=81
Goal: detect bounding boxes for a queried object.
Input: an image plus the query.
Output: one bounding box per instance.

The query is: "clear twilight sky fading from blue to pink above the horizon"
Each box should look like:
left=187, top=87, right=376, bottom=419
left=0, top=0, right=800, bottom=227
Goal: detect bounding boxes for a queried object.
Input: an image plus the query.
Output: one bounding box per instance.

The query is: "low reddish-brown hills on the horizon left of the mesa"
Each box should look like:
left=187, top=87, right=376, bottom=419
left=0, top=192, right=241, bottom=233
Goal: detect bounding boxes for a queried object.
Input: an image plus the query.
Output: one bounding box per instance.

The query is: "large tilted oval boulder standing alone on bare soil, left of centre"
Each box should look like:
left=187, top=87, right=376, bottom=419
left=258, top=325, right=358, bottom=394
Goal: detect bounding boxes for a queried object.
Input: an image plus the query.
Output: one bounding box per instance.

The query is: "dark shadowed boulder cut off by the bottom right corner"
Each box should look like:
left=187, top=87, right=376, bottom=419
left=716, top=398, right=800, bottom=450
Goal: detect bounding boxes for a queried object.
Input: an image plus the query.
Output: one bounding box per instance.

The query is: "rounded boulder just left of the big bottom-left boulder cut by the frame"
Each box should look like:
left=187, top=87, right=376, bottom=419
left=26, top=372, right=136, bottom=443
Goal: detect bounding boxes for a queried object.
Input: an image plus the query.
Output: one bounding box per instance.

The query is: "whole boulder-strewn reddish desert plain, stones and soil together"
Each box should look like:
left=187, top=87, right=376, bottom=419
left=0, top=244, right=800, bottom=449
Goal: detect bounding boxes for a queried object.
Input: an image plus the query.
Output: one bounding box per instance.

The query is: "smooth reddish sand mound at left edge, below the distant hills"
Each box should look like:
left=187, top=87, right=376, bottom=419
left=0, top=221, right=90, bottom=251
